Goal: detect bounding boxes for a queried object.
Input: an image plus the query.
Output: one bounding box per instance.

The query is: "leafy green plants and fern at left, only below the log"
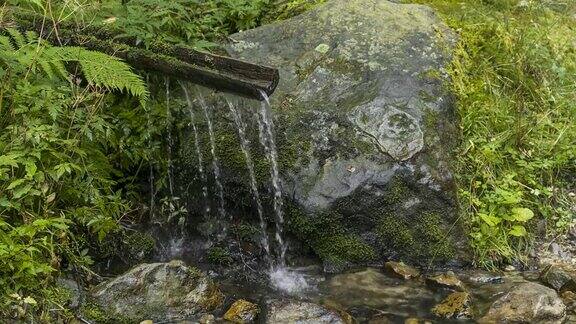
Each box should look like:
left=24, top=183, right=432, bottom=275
left=0, top=25, right=147, bottom=316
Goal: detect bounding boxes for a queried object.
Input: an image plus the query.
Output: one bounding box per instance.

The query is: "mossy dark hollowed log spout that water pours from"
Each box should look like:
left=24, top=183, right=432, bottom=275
left=8, top=13, right=279, bottom=100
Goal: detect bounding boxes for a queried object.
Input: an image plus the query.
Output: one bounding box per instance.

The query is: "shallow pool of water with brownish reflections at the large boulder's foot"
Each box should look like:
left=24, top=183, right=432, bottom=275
left=210, top=266, right=534, bottom=324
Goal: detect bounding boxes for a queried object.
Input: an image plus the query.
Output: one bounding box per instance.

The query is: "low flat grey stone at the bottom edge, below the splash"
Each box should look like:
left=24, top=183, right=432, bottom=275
left=266, top=300, right=348, bottom=324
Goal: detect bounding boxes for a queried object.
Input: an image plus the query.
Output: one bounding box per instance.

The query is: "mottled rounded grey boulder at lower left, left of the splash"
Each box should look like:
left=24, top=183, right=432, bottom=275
left=92, top=261, right=224, bottom=322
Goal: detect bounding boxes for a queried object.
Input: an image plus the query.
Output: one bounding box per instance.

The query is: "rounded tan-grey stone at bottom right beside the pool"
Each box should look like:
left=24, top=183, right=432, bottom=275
left=479, top=282, right=566, bottom=324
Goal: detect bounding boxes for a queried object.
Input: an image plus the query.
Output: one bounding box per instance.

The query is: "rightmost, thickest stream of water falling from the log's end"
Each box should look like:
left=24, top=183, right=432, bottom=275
left=256, top=91, right=287, bottom=268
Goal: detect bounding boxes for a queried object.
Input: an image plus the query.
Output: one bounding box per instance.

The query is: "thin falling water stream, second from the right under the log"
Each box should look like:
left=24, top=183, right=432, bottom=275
left=225, top=98, right=272, bottom=266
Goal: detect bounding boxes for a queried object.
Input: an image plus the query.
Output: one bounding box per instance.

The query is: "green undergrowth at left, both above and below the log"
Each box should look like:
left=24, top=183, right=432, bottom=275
left=0, top=0, right=320, bottom=322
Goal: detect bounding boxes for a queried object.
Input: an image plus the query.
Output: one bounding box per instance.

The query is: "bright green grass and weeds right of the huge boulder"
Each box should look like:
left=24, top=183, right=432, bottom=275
left=406, top=0, right=576, bottom=267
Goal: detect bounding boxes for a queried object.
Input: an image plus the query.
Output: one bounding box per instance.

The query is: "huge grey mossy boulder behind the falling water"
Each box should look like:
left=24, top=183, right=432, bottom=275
left=178, top=0, right=466, bottom=270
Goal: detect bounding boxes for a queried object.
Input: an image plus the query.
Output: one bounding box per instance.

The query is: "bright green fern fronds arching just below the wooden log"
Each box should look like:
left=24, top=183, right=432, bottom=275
left=0, top=28, right=149, bottom=102
